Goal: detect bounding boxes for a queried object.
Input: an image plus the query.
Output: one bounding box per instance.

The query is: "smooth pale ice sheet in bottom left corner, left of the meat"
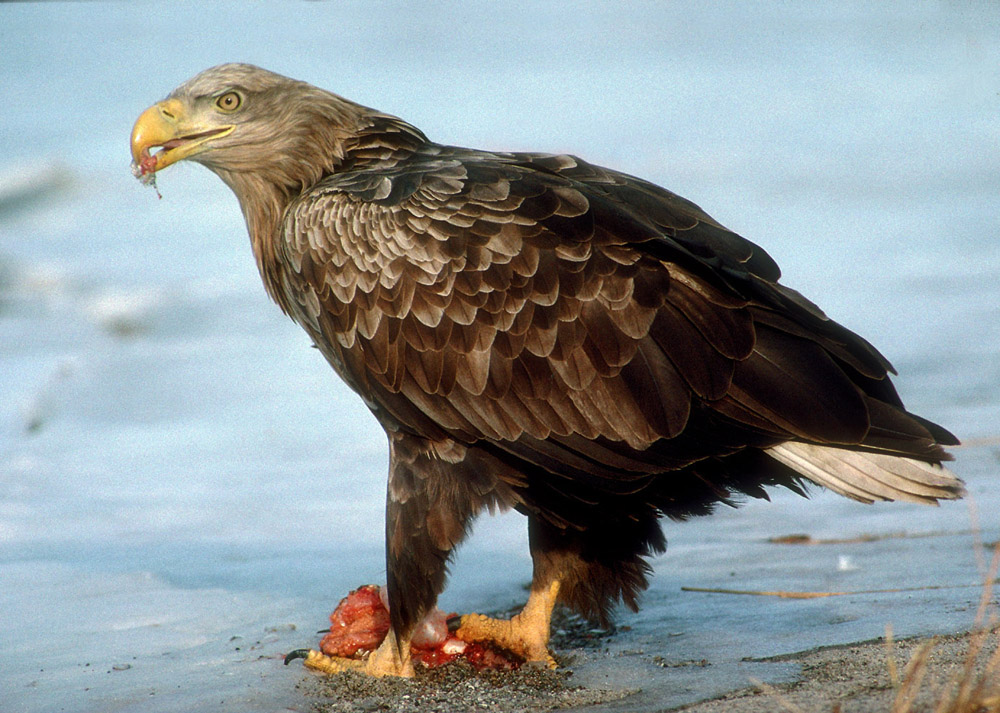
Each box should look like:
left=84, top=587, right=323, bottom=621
left=0, top=560, right=301, bottom=711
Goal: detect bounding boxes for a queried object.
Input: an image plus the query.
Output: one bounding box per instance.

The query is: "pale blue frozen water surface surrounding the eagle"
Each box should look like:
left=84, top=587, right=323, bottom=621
left=0, top=2, right=1000, bottom=713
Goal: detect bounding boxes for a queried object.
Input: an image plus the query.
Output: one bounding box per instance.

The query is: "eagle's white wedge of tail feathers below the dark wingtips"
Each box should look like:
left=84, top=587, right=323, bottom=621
left=767, top=442, right=965, bottom=504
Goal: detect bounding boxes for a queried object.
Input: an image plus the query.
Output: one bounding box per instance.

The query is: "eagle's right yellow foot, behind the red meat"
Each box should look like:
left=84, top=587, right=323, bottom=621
left=454, top=579, right=559, bottom=668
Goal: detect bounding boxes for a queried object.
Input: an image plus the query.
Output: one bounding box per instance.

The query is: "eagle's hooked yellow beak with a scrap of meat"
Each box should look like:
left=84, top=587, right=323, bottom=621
left=132, top=99, right=236, bottom=175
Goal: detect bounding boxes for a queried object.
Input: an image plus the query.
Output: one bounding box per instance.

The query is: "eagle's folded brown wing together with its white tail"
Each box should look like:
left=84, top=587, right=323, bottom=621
left=285, top=147, right=960, bottom=512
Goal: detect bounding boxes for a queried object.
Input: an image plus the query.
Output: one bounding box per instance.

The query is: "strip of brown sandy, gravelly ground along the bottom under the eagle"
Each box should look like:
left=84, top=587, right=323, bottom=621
left=299, top=604, right=1000, bottom=713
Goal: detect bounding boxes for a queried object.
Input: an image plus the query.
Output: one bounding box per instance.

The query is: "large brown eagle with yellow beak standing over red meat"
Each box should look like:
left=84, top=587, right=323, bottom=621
left=131, top=64, right=963, bottom=676
